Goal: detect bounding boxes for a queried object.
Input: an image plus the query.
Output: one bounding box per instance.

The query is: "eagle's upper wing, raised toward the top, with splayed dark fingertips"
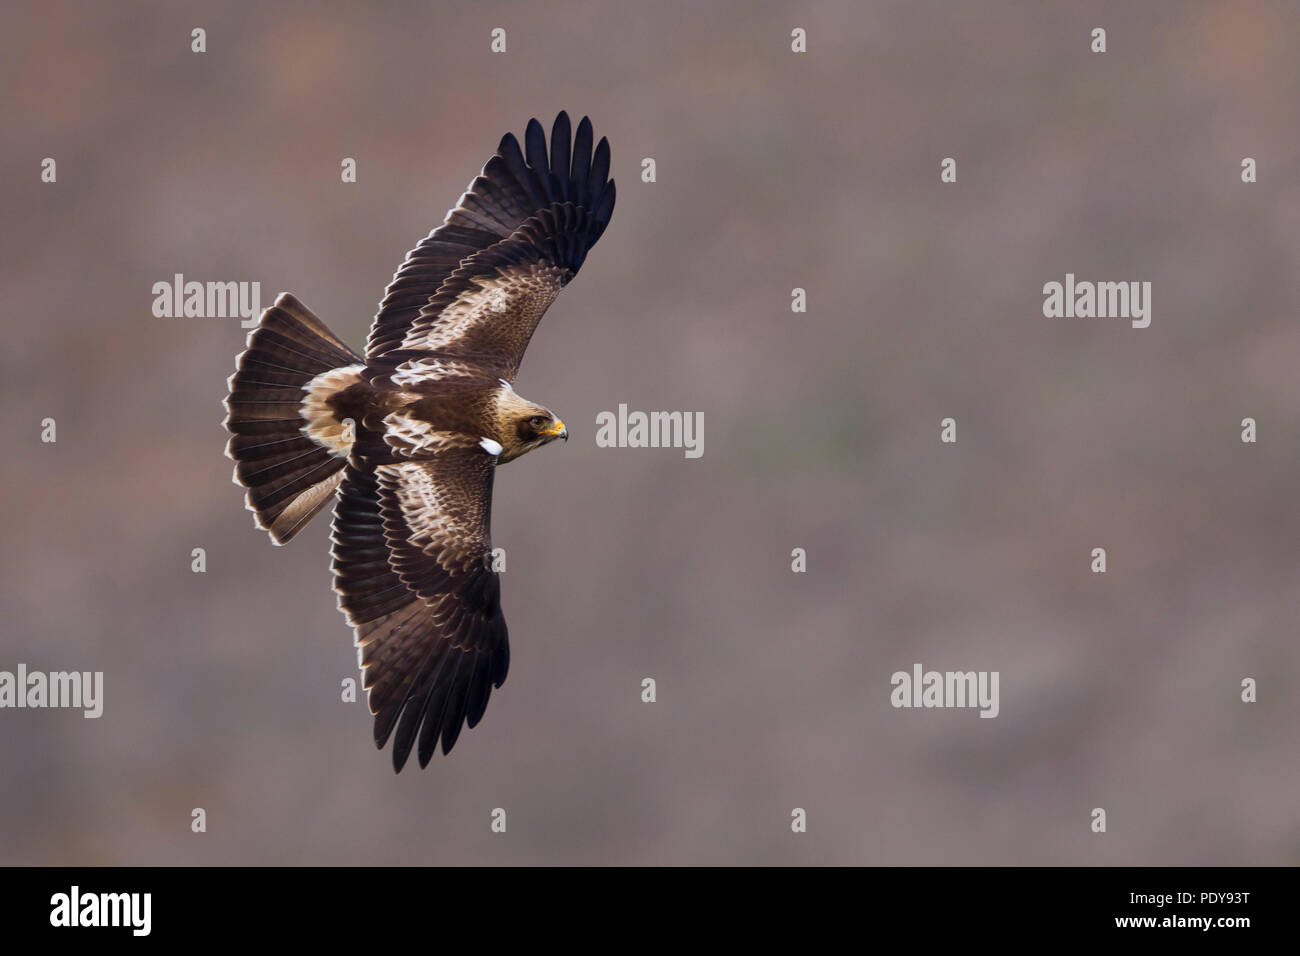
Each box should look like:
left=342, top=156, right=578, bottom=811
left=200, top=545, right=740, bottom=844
left=367, top=113, right=615, bottom=390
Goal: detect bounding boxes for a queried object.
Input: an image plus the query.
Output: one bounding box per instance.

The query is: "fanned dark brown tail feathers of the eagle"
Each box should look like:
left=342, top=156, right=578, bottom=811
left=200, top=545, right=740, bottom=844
left=225, top=294, right=361, bottom=544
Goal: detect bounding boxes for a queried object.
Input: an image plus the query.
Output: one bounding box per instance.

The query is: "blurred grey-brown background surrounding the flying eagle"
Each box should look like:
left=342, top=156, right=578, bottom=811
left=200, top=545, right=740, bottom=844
left=0, top=3, right=1300, bottom=864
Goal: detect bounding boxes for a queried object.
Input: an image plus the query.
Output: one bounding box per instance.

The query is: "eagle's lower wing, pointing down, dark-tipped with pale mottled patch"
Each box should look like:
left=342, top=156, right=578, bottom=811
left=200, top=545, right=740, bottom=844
left=333, top=447, right=510, bottom=770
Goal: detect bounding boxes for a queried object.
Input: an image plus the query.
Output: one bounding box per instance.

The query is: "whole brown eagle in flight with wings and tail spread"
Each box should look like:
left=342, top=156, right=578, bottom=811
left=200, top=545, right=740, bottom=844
left=225, top=113, right=614, bottom=771
